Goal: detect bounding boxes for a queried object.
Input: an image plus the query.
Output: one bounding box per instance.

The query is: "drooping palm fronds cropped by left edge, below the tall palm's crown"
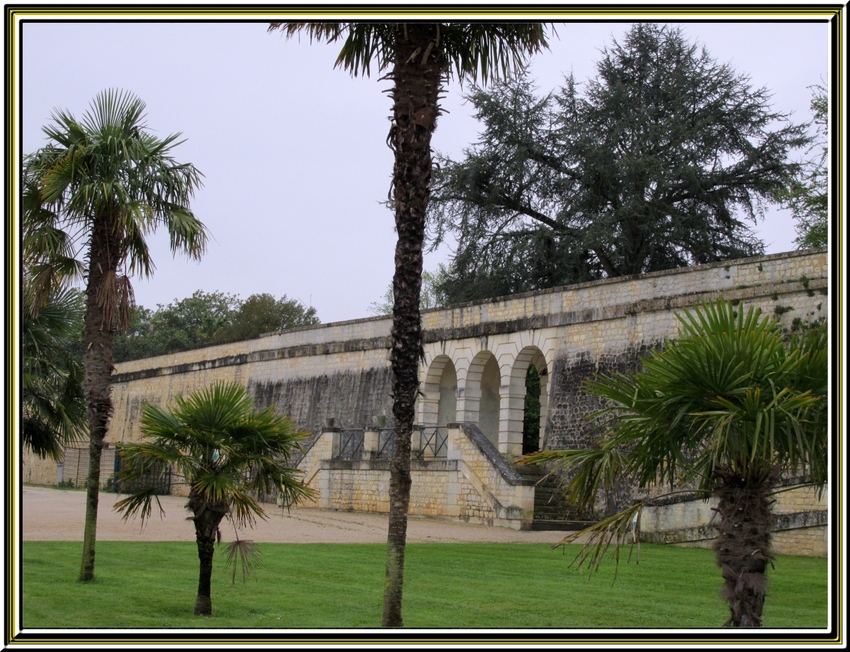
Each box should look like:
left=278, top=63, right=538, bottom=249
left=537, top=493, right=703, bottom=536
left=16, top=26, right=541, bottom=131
left=21, top=277, right=87, bottom=461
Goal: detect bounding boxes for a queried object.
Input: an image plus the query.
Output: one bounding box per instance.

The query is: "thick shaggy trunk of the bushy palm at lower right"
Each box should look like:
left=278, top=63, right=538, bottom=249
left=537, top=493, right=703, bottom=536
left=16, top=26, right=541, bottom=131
left=714, top=469, right=777, bottom=627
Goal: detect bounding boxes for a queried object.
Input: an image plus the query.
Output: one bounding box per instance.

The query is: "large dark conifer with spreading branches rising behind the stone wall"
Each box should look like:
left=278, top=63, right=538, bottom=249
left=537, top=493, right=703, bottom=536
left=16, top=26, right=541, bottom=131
left=429, top=23, right=806, bottom=303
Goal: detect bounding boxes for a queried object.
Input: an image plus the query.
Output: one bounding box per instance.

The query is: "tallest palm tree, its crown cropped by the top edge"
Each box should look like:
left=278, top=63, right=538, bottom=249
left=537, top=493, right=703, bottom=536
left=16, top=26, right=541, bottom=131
left=269, top=22, right=546, bottom=627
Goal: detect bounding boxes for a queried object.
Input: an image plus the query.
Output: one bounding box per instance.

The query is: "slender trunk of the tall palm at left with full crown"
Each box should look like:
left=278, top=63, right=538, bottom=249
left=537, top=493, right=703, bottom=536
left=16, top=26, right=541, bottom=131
left=79, top=215, right=120, bottom=582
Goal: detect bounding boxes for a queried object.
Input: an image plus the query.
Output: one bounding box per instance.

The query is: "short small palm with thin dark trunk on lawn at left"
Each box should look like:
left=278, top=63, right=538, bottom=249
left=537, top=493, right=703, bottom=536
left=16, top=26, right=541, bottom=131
left=115, top=383, right=312, bottom=615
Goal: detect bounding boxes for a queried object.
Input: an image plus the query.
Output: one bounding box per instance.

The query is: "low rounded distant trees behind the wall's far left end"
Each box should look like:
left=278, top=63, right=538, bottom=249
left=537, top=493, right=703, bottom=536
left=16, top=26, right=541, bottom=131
left=115, top=290, right=320, bottom=362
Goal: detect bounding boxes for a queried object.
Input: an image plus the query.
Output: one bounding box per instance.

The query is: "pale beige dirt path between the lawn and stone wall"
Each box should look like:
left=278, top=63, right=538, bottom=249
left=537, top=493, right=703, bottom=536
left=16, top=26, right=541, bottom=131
left=22, top=486, right=564, bottom=544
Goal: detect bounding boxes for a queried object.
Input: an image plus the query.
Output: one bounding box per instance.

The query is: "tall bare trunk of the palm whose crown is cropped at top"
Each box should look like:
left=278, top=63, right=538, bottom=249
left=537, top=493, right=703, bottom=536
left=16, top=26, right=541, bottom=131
left=382, top=24, right=443, bottom=627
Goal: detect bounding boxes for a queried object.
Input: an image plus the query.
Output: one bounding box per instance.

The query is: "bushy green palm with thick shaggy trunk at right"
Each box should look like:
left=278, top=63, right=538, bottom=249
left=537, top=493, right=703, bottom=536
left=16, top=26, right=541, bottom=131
left=522, top=300, right=828, bottom=627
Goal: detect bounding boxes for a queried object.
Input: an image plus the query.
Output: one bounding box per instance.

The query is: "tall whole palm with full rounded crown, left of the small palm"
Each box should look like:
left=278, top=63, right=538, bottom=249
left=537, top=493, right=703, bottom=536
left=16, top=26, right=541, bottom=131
left=23, top=90, right=207, bottom=581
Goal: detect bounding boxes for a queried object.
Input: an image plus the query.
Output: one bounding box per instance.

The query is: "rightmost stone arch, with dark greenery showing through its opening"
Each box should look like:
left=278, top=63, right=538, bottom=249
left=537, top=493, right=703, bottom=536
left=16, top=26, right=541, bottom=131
left=500, top=345, right=549, bottom=457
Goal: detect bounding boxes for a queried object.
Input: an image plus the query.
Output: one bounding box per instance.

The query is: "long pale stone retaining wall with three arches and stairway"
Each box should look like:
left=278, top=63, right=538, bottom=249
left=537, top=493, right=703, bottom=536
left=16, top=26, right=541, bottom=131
left=23, top=250, right=830, bottom=549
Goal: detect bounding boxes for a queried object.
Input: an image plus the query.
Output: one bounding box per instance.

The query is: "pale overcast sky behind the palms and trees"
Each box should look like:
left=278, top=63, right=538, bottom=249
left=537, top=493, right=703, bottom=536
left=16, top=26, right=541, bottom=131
left=22, top=21, right=829, bottom=322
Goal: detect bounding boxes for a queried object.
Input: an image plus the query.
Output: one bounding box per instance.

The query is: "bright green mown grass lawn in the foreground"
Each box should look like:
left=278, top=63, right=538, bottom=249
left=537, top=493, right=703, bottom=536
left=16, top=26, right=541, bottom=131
left=22, top=541, right=827, bottom=629
